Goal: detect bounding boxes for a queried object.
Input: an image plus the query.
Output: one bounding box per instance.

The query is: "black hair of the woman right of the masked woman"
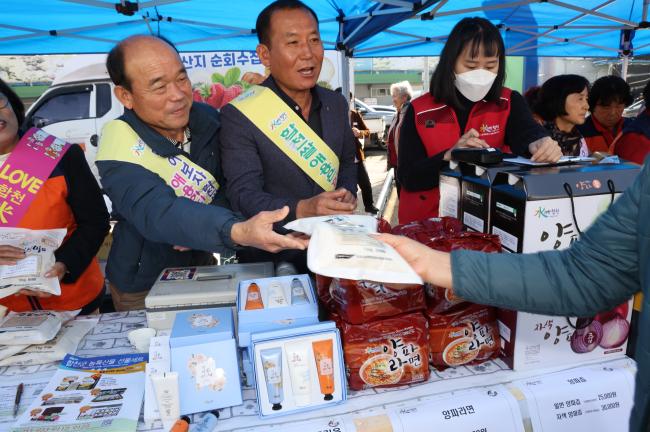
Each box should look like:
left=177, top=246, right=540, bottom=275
left=536, top=74, right=589, bottom=121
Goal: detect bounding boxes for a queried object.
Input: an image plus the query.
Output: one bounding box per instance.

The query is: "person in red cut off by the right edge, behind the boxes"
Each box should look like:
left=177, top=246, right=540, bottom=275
left=612, top=81, right=650, bottom=164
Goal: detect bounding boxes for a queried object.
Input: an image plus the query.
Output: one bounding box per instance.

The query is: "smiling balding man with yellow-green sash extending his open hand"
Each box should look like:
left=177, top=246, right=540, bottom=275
left=97, top=36, right=305, bottom=310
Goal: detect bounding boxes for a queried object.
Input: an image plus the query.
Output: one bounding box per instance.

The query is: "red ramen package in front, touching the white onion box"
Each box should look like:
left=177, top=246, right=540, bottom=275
left=427, top=304, right=499, bottom=368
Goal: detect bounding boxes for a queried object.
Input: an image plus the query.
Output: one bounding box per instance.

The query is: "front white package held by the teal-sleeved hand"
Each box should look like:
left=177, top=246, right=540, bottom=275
left=307, top=223, right=422, bottom=284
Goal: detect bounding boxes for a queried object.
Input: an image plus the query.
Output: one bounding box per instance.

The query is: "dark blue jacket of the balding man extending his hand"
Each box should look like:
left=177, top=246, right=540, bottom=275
left=97, top=103, right=241, bottom=292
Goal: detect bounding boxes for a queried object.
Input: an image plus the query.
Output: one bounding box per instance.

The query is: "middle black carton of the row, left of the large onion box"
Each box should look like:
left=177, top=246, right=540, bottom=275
left=459, top=162, right=522, bottom=233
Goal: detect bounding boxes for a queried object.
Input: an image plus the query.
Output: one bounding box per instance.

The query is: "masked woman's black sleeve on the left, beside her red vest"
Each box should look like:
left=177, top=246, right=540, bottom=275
left=397, top=105, right=446, bottom=192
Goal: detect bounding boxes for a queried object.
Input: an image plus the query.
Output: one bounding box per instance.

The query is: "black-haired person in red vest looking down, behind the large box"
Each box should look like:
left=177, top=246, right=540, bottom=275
left=577, top=75, right=634, bottom=153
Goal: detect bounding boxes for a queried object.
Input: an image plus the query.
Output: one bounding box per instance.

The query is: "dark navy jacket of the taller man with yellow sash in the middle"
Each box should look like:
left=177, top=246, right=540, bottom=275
left=221, top=80, right=357, bottom=222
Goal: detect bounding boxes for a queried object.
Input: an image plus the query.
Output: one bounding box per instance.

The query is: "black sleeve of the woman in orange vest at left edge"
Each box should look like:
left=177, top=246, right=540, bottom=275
left=55, top=145, right=110, bottom=283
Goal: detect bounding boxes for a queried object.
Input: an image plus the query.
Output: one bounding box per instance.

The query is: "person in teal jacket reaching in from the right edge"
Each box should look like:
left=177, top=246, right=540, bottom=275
left=378, top=160, right=650, bottom=432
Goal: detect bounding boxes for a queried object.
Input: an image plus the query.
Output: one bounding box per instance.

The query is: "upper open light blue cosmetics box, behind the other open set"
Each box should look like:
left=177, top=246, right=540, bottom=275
left=237, top=274, right=318, bottom=348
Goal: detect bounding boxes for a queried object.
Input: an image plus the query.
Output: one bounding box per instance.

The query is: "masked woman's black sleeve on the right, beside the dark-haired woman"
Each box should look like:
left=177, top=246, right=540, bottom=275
left=506, top=91, right=548, bottom=157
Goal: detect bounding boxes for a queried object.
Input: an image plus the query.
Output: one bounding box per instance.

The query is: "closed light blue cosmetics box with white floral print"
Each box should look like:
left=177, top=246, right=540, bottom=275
left=169, top=307, right=242, bottom=414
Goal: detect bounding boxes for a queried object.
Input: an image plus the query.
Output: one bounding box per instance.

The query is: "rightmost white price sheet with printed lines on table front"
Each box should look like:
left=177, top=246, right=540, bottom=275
left=513, top=365, right=634, bottom=432
